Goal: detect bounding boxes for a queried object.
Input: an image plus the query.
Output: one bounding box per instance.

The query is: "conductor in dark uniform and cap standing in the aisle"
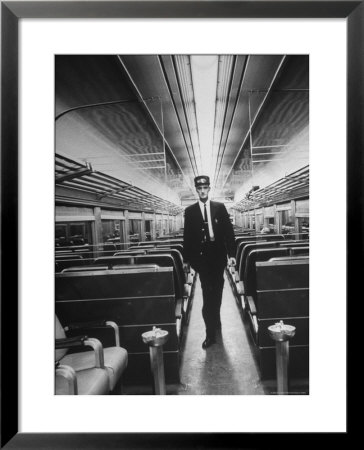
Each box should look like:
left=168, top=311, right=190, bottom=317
left=183, top=175, right=236, bottom=349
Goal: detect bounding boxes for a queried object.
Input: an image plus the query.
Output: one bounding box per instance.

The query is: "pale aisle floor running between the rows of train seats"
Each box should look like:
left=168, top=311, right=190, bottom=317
left=124, top=274, right=308, bottom=395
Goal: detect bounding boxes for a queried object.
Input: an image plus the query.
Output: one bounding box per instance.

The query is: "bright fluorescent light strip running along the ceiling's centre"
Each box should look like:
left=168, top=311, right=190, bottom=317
left=191, top=55, right=218, bottom=180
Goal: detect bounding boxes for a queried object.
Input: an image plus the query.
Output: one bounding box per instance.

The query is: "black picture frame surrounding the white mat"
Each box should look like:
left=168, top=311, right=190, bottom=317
left=1, top=0, right=356, bottom=449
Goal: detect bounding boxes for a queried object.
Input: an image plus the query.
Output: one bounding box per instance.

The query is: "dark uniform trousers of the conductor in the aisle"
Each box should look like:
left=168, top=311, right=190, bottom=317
left=196, top=243, right=226, bottom=338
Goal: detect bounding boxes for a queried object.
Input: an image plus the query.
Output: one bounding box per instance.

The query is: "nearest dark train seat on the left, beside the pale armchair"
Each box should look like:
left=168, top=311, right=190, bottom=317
left=55, top=266, right=182, bottom=384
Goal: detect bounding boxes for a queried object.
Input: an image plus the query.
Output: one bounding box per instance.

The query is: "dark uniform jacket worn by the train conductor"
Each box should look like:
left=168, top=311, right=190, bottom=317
left=183, top=201, right=236, bottom=267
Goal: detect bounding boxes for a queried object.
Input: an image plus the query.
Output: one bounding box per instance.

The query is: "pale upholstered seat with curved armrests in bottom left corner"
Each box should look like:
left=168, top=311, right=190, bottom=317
left=55, top=316, right=128, bottom=394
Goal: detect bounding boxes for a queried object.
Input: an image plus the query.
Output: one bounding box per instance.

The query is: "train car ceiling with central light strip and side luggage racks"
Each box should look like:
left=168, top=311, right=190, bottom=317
left=55, top=55, right=309, bottom=212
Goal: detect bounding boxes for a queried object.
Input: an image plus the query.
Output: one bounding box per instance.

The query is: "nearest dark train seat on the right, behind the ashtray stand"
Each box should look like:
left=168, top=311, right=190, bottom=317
left=247, top=258, right=309, bottom=378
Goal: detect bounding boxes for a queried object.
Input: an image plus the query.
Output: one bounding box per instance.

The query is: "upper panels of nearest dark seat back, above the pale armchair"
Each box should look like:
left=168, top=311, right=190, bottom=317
left=55, top=265, right=175, bottom=328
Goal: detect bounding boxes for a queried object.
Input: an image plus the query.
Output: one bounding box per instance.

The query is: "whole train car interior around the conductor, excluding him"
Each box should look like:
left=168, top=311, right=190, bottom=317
left=54, top=55, right=310, bottom=395
